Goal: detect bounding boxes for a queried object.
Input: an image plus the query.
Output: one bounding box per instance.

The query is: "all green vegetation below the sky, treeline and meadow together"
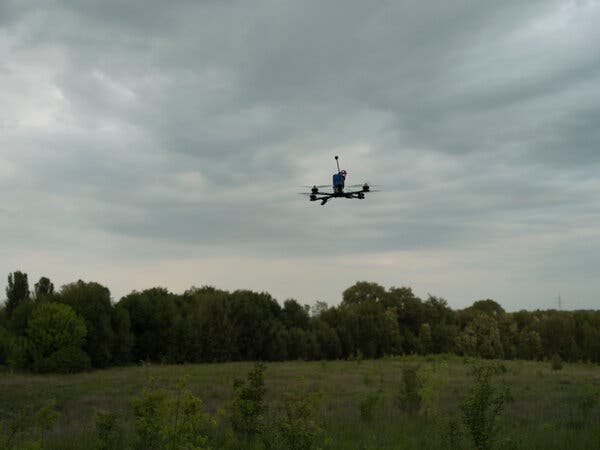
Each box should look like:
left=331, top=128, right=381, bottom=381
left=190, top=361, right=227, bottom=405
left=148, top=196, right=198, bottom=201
left=0, top=272, right=600, bottom=450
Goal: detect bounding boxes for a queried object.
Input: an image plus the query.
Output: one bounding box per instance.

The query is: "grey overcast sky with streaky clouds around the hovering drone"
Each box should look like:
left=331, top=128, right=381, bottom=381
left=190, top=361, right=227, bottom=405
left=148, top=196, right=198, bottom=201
left=0, top=0, right=600, bottom=310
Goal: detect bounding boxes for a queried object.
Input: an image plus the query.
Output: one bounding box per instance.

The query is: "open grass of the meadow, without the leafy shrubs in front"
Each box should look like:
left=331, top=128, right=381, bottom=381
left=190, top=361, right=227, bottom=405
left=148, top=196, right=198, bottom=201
left=0, top=356, right=600, bottom=449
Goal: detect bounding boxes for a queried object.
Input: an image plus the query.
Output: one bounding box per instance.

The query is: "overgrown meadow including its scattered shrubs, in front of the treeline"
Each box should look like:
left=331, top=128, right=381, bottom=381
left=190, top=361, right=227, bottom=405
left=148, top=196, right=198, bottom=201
left=0, top=355, right=600, bottom=450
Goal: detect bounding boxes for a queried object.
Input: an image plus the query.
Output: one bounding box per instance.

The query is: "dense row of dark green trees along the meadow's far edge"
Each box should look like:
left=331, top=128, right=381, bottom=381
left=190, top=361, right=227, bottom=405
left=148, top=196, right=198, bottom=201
left=0, top=272, right=600, bottom=372
